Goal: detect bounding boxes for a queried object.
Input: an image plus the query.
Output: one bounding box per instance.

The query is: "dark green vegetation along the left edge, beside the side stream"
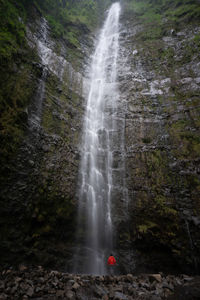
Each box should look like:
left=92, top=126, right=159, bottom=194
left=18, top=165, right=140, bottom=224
left=0, top=0, right=37, bottom=175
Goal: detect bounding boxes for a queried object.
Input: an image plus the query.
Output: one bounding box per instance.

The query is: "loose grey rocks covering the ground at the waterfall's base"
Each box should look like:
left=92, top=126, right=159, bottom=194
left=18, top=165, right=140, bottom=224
left=0, top=266, right=200, bottom=300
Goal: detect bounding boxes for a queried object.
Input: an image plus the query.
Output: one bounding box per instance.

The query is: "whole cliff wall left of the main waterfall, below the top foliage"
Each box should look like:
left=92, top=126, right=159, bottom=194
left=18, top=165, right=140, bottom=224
left=1, top=0, right=101, bottom=269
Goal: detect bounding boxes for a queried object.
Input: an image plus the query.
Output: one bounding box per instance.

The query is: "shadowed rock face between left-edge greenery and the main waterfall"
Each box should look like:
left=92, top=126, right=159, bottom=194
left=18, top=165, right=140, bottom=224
left=1, top=8, right=89, bottom=268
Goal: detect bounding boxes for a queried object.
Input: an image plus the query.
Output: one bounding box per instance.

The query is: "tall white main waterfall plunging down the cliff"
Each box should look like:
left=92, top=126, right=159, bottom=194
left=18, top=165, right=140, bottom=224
left=75, top=3, right=120, bottom=274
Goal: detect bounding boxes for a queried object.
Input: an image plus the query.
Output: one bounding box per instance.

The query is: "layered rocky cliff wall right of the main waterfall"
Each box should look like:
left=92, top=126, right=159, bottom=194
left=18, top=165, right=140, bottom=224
left=117, top=1, right=200, bottom=272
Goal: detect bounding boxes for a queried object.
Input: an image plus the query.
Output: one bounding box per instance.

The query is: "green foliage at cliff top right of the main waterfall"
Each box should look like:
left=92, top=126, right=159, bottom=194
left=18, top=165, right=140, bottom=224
left=125, top=0, right=200, bottom=40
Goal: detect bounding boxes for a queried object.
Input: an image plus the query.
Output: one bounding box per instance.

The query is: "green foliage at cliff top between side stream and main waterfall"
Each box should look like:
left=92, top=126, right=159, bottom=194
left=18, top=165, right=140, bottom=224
left=31, top=0, right=110, bottom=47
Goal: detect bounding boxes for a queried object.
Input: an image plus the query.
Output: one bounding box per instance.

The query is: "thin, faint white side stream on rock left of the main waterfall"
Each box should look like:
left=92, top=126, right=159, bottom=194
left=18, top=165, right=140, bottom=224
left=27, top=18, right=82, bottom=132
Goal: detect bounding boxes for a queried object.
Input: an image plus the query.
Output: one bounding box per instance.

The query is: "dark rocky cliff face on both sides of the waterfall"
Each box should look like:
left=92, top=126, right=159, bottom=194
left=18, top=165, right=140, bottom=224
left=0, top=1, right=200, bottom=272
